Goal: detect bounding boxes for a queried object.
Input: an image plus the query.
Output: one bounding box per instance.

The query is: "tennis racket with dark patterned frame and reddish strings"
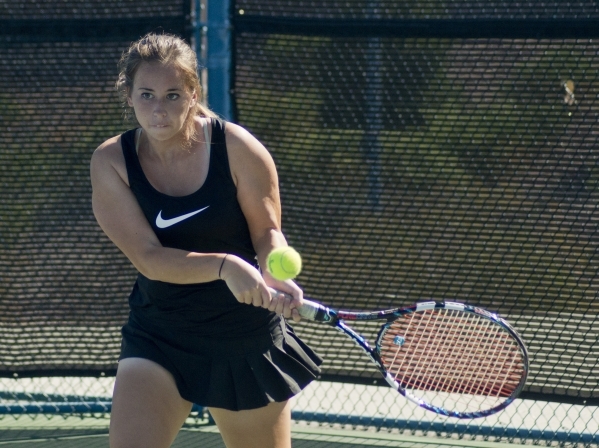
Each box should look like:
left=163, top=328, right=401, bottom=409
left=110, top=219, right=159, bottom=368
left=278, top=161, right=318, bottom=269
left=271, top=290, right=528, bottom=418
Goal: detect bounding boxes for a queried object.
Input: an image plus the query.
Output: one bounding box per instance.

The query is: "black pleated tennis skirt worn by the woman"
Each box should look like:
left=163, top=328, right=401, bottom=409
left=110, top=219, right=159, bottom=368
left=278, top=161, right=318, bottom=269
left=119, top=316, right=322, bottom=411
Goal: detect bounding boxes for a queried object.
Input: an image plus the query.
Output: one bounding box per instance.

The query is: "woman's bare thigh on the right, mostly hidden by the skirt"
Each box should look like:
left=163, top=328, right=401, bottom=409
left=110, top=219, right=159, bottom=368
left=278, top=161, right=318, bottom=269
left=209, top=401, right=291, bottom=448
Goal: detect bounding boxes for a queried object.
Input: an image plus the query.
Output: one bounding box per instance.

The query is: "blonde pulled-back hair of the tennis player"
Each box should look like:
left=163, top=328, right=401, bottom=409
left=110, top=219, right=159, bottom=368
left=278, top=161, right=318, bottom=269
left=115, top=33, right=218, bottom=145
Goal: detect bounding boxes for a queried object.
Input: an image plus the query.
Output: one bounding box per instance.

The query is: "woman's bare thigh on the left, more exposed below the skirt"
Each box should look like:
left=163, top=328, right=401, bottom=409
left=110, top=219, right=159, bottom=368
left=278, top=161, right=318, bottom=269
left=110, top=358, right=192, bottom=448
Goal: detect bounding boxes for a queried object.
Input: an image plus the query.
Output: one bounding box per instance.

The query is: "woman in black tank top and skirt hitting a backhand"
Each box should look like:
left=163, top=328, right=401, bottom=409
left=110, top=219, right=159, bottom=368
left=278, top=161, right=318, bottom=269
left=91, top=34, right=321, bottom=448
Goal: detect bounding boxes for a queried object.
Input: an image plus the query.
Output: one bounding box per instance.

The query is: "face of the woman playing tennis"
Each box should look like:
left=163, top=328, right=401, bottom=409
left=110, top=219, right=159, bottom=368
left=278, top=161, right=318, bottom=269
left=127, top=62, right=197, bottom=141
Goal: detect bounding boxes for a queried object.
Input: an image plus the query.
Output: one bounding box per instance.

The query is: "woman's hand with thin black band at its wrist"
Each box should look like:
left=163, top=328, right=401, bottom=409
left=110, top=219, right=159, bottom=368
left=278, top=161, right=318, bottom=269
left=220, top=254, right=272, bottom=309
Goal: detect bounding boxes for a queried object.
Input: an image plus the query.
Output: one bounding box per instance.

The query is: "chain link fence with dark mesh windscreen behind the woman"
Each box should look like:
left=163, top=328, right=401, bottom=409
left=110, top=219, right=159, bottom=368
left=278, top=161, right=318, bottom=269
left=0, top=0, right=599, bottom=446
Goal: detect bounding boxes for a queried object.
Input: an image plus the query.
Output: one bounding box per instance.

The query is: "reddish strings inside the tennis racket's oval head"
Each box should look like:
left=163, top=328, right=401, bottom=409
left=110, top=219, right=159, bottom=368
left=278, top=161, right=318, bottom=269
left=380, top=309, right=523, bottom=397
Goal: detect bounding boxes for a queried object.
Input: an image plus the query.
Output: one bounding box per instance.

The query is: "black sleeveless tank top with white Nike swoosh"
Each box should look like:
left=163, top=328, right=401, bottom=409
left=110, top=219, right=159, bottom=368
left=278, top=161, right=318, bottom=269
left=121, top=119, right=279, bottom=337
